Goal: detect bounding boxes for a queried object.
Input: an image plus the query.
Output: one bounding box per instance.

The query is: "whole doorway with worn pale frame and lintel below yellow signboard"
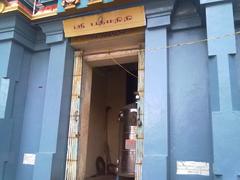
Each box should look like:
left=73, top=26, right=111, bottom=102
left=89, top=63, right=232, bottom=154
left=65, top=28, right=144, bottom=180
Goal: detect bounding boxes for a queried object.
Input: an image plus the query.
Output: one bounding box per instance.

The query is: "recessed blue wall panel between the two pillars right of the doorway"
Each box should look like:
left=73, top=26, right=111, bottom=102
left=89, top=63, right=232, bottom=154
left=169, top=28, right=213, bottom=180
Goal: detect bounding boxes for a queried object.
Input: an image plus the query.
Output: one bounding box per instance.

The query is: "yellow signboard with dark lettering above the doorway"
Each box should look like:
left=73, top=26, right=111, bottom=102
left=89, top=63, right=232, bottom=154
left=63, top=6, right=146, bottom=37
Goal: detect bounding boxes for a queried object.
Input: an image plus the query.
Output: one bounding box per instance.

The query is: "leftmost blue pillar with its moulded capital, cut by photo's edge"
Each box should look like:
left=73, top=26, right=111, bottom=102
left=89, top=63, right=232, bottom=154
left=0, top=14, right=34, bottom=180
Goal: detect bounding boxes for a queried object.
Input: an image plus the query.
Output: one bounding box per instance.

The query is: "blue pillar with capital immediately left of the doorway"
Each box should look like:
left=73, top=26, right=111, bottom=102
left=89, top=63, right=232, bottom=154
left=33, top=21, right=73, bottom=180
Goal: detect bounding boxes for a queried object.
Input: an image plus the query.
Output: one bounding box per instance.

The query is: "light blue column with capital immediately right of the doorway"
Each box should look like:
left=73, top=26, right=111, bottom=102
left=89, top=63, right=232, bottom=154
left=143, top=3, right=173, bottom=180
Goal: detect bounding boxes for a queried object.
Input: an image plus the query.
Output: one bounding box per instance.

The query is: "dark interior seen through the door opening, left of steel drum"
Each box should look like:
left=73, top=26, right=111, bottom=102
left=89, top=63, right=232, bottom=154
left=84, top=63, right=137, bottom=180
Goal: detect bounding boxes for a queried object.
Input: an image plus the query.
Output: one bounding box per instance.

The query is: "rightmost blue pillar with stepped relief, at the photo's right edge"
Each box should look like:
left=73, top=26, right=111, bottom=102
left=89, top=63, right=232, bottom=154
left=201, top=0, right=240, bottom=180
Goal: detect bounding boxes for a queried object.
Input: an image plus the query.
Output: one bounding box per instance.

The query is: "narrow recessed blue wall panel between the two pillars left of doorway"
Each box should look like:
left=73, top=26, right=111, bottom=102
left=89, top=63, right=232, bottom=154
left=16, top=51, right=49, bottom=180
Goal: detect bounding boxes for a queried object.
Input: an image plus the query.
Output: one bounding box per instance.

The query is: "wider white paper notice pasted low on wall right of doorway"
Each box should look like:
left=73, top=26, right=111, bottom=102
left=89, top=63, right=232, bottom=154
left=177, top=161, right=209, bottom=176
